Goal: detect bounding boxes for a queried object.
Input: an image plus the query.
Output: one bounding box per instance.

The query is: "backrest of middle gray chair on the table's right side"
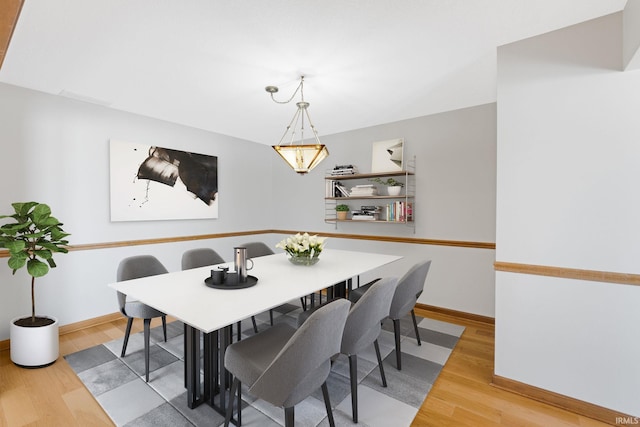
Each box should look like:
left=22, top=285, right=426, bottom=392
left=340, top=277, right=398, bottom=355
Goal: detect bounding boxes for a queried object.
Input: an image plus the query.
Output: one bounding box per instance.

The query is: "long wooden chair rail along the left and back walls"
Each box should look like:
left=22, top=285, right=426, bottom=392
left=0, top=230, right=496, bottom=258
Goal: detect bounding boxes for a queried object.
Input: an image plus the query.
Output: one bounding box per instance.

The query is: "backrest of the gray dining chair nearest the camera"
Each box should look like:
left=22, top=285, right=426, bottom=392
left=249, top=299, right=351, bottom=408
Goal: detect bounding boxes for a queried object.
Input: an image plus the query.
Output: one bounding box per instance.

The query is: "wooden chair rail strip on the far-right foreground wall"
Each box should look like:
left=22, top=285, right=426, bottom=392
left=493, top=261, right=640, bottom=286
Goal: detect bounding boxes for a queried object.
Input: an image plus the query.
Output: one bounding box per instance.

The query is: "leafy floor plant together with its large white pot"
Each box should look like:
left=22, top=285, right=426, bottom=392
left=0, top=202, right=69, bottom=367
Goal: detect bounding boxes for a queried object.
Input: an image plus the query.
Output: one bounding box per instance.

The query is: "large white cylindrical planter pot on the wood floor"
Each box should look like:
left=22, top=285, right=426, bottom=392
left=9, top=316, right=59, bottom=368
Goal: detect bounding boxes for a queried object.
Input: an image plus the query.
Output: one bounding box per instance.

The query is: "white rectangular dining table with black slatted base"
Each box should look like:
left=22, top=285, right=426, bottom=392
left=108, top=249, right=402, bottom=410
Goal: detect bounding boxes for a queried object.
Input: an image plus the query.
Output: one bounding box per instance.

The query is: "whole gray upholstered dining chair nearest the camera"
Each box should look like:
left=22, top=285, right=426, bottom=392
left=224, top=299, right=351, bottom=427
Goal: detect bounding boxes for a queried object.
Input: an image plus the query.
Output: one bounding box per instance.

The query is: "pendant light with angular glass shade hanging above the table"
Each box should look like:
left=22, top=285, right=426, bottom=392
left=265, top=76, right=329, bottom=175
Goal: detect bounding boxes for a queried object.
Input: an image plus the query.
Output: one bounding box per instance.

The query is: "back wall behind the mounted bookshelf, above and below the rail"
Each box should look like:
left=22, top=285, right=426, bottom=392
left=273, top=104, right=496, bottom=317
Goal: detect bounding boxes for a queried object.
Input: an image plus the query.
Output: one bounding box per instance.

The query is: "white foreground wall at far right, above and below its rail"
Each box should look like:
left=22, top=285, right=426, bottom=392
left=495, top=14, right=640, bottom=415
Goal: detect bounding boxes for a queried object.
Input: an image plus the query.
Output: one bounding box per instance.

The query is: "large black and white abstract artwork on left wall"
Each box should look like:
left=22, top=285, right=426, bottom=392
left=109, top=139, right=218, bottom=221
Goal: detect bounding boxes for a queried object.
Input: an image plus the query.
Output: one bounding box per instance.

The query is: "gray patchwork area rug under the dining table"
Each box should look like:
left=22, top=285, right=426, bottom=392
left=65, top=304, right=464, bottom=427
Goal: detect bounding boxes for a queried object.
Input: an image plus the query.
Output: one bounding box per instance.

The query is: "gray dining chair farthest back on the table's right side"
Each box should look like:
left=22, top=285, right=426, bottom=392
left=349, top=260, right=431, bottom=371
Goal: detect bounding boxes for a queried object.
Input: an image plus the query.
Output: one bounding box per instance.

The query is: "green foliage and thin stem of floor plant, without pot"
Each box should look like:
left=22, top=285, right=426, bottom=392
left=0, top=202, right=69, bottom=324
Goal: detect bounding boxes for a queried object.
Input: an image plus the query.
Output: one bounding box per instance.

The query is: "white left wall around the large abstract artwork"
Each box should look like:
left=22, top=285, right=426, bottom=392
left=0, top=84, right=272, bottom=340
